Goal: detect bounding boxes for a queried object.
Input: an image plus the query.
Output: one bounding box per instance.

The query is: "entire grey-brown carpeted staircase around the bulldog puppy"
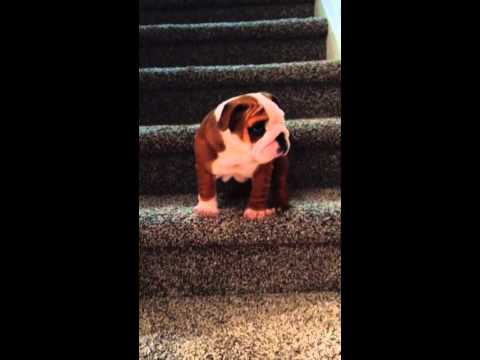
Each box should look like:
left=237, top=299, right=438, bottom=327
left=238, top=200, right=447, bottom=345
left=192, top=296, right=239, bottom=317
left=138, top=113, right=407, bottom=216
left=139, top=0, right=341, bottom=359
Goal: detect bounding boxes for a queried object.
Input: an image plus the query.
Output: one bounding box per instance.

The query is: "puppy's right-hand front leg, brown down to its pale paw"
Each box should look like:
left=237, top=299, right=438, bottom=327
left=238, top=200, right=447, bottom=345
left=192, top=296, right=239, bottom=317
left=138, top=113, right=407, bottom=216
left=243, top=162, right=275, bottom=219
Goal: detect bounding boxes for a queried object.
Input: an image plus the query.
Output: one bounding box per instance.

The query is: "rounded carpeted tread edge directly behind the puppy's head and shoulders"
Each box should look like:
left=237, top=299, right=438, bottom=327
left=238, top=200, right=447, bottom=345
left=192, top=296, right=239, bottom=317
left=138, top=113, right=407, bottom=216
left=139, top=117, right=341, bottom=157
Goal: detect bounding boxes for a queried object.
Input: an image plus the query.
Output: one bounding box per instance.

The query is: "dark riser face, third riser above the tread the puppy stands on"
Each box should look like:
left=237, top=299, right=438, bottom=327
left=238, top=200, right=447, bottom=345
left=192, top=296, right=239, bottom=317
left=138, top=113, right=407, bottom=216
left=140, top=38, right=326, bottom=67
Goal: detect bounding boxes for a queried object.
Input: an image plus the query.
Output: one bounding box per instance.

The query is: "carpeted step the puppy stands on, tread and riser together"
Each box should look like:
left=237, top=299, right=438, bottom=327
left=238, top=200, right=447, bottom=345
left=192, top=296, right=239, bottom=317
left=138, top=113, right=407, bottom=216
left=140, top=189, right=340, bottom=297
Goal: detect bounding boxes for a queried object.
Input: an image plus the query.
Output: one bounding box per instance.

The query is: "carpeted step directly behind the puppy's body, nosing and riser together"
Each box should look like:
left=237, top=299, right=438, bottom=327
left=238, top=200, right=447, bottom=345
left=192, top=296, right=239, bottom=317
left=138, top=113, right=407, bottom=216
left=139, top=118, right=341, bottom=195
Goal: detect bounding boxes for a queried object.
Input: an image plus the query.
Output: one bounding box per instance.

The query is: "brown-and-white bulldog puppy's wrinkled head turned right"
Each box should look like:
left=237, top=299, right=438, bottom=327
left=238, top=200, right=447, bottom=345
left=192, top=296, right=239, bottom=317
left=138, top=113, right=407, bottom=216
left=214, top=92, right=290, bottom=164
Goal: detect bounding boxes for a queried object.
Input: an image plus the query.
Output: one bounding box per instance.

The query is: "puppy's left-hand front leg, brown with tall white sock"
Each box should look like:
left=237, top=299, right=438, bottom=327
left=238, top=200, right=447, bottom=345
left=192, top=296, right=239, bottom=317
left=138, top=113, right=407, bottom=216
left=194, top=164, right=218, bottom=216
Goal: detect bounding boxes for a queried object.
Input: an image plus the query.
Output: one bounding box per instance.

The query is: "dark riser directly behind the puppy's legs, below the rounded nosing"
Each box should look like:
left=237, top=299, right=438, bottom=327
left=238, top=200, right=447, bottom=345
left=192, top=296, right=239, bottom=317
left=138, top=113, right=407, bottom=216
left=139, top=149, right=341, bottom=195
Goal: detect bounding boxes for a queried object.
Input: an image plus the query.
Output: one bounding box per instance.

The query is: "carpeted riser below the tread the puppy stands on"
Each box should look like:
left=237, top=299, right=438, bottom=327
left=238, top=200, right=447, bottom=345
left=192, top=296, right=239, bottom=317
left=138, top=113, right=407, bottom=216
left=140, top=245, right=341, bottom=297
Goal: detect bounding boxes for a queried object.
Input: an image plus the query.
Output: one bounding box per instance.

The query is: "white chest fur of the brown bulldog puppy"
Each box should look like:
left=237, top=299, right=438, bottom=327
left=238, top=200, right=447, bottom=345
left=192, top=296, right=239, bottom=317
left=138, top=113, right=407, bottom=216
left=211, top=131, right=259, bottom=182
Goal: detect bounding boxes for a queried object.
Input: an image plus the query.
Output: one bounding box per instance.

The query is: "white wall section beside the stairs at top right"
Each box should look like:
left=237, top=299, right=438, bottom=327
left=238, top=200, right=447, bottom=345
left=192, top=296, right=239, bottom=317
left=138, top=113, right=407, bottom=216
left=315, top=0, right=342, bottom=60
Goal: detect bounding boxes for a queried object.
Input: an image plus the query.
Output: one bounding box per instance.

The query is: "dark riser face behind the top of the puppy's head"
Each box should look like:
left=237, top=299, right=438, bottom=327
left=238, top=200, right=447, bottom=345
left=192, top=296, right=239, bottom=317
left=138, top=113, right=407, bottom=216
left=139, top=84, right=341, bottom=125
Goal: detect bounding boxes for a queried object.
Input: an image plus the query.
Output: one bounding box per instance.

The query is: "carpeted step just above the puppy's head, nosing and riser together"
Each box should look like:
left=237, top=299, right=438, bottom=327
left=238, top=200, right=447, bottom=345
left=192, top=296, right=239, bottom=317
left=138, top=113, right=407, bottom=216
left=139, top=60, right=341, bottom=125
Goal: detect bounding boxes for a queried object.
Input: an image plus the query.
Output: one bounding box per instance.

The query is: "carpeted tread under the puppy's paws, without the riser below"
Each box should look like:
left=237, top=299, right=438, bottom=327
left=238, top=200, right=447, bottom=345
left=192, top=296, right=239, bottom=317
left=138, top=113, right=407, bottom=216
left=139, top=188, right=341, bottom=248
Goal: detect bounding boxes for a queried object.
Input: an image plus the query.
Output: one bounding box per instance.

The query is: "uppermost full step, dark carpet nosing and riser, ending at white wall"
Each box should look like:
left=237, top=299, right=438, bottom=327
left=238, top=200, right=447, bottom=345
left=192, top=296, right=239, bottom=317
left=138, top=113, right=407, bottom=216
left=139, top=17, right=328, bottom=67
